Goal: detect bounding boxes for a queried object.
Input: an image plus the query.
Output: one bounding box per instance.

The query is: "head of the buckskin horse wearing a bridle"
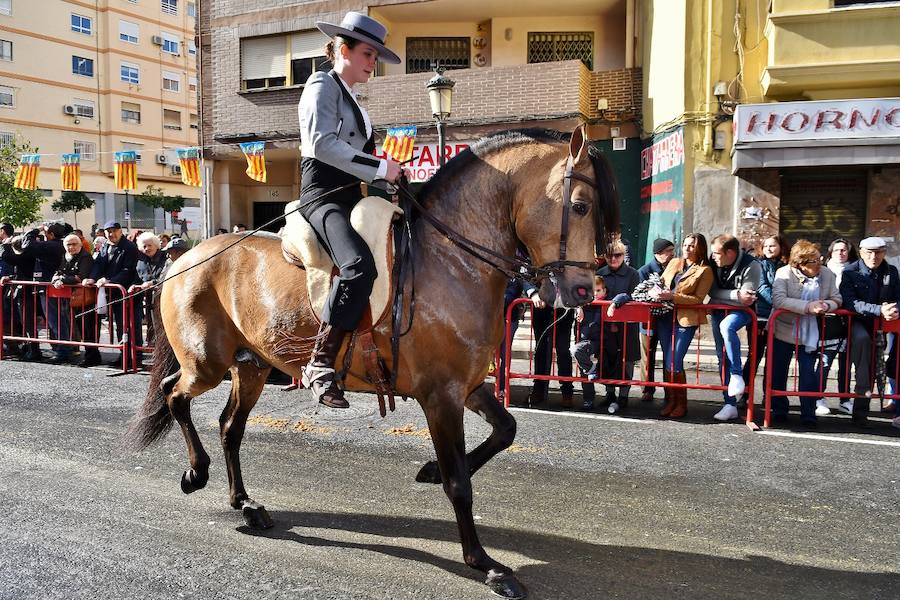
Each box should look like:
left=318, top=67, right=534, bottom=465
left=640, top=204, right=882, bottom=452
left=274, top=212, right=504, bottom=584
left=513, top=126, right=619, bottom=307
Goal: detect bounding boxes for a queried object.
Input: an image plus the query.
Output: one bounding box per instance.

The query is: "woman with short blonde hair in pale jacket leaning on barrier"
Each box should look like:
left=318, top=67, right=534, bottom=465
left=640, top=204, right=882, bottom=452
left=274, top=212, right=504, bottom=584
left=770, top=240, right=841, bottom=428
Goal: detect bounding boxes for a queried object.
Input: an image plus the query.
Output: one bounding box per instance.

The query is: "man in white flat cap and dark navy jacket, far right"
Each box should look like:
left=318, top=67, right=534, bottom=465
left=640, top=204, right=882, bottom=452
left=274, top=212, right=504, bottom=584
left=841, top=237, right=900, bottom=427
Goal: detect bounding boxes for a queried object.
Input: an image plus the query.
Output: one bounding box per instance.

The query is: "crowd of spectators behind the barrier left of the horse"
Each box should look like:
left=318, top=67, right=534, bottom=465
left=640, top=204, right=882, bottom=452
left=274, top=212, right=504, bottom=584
left=0, top=221, right=189, bottom=367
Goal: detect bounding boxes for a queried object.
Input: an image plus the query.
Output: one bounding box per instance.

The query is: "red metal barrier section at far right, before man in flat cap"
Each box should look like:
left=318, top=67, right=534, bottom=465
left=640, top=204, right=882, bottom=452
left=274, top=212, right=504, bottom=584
left=763, top=308, right=900, bottom=427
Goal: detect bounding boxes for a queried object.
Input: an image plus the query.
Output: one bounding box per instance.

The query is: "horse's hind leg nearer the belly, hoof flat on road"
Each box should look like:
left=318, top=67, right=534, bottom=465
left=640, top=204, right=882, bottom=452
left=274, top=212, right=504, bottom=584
left=219, top=363, right=272, bottom=529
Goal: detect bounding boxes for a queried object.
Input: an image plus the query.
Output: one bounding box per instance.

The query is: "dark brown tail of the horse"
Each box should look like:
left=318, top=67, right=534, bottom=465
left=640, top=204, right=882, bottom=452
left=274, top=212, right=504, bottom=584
left=125, top=294, right=180, bottom=450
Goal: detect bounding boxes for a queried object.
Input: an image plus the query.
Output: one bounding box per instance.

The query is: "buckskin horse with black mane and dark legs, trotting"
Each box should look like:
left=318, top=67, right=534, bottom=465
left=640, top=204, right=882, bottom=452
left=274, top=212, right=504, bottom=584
left=129, top=127, right=618, bottom=598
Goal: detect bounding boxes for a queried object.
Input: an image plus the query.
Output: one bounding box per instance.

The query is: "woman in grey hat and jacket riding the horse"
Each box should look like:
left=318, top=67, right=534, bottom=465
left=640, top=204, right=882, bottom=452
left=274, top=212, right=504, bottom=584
left=299, top=12, right=400, bottom=408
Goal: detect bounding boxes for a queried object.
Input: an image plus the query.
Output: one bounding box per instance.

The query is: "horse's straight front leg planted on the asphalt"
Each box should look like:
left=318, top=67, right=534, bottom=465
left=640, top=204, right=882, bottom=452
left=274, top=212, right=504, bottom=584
left=425, top=397, right=526, bottom=598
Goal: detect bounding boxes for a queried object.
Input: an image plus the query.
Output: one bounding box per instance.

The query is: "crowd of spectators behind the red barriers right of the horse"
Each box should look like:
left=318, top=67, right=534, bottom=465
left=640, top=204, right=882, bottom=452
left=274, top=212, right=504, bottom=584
left=500, top=233, right=900, bottom=428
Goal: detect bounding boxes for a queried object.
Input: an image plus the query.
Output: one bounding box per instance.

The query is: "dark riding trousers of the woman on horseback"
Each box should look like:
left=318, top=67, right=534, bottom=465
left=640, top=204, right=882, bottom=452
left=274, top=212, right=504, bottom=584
left=305, top=202, right=378, bottom=331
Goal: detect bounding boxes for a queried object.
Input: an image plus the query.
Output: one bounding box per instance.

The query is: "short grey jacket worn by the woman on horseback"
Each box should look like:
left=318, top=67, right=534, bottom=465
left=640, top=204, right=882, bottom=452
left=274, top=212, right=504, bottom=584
left=297, top=71, right=381, bottom=182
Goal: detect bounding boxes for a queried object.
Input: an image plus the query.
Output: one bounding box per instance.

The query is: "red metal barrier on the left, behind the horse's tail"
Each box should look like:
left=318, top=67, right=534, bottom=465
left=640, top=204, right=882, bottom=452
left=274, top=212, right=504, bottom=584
left=0, top=280, right=131, bottom=371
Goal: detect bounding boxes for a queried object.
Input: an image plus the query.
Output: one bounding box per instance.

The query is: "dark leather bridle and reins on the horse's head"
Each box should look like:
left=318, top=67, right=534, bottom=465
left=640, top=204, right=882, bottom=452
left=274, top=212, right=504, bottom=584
left=398, top=155, right=600, bottom=284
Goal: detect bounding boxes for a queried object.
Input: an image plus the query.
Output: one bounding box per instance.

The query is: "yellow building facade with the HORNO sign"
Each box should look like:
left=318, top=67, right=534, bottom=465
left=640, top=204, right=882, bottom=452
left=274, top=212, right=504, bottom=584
left=639, top=0, right=900, bottom=261
